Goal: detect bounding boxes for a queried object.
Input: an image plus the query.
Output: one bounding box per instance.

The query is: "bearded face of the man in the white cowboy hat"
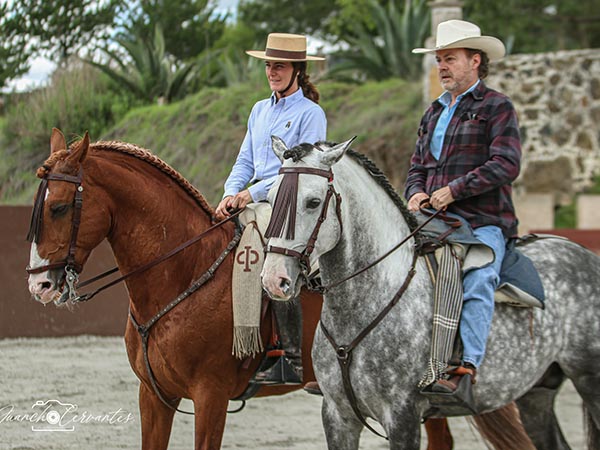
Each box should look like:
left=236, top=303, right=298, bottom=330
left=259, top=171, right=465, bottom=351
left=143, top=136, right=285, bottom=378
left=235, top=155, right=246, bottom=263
left=435, top=48, right=481, bottom=96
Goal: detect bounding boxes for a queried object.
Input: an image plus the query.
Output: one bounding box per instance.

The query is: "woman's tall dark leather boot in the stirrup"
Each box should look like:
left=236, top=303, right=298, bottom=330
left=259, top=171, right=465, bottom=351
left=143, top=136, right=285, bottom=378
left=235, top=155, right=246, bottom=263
left=254, top=298, right=303, bottom=385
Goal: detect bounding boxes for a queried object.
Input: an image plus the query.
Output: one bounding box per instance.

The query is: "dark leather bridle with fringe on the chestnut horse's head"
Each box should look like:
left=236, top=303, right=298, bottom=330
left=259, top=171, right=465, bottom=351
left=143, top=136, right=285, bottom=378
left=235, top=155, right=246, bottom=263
left=25, top=169, right=83, bottom=304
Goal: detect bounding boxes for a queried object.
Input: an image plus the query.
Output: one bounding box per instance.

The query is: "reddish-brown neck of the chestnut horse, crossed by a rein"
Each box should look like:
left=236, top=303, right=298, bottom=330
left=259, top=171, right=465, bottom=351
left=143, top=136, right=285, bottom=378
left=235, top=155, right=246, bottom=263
left=84, top=157, right=229, bottom=310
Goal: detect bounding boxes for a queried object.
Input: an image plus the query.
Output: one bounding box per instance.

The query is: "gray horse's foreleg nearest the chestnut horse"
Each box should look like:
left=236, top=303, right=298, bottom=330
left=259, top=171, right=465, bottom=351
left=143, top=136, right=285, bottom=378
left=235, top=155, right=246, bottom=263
left=321, top=397, right=363, bottom=450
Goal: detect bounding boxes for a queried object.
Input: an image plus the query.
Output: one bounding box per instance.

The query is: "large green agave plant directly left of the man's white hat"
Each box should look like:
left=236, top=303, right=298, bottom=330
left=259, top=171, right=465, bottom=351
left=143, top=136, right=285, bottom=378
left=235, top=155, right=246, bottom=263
left=328, top=0, right=430, bottom=80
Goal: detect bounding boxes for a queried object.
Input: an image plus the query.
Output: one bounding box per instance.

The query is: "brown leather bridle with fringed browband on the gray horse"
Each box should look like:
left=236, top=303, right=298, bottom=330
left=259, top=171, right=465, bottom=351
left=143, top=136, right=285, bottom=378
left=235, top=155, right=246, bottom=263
left=265, top=167, right=342, bottom=277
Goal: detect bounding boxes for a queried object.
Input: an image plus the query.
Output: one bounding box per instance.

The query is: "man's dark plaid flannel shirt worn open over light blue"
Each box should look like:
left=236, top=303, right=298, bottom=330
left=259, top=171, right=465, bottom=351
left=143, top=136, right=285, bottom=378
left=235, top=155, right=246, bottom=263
left=404, top=82, right=521, bottom=237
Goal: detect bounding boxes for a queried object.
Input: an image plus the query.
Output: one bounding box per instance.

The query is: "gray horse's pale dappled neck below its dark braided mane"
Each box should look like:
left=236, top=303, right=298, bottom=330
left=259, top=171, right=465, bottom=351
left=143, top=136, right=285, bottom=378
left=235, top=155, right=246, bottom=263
left=320, top=158, right=413, bottom=323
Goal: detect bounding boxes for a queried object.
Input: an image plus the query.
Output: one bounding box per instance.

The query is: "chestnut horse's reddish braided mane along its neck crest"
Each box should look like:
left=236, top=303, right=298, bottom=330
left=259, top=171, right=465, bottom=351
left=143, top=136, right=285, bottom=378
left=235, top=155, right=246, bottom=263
left=37, top=141, right=214, bottom=217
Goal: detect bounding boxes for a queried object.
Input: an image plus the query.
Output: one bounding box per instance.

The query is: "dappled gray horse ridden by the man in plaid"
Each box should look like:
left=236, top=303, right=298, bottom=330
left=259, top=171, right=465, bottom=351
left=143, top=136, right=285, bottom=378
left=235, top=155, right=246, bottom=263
left=263, top=138, right=600, bottom=449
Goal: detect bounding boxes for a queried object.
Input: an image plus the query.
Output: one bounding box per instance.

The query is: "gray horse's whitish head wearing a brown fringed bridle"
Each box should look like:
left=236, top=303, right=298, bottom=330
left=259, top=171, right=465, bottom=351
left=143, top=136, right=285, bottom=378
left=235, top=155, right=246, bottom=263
left=262, top=136, right=354, bottom=300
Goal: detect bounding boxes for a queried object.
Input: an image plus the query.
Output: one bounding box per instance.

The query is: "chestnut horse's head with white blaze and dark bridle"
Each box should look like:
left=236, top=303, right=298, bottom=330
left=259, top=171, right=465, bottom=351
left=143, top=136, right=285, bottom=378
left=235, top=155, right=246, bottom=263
left=27, top=128, right=107, bottom=304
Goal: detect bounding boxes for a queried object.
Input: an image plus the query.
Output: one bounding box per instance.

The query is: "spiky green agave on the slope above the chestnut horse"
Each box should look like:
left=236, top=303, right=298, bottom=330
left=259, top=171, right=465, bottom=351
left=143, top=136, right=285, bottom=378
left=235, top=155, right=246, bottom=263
left=86, top=25, right=195, bottom=103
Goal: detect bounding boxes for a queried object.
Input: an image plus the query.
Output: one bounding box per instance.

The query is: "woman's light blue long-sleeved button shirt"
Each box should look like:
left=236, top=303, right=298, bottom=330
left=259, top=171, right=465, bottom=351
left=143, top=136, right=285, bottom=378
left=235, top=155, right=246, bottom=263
left=223, top=89, right=327, bottom=202
